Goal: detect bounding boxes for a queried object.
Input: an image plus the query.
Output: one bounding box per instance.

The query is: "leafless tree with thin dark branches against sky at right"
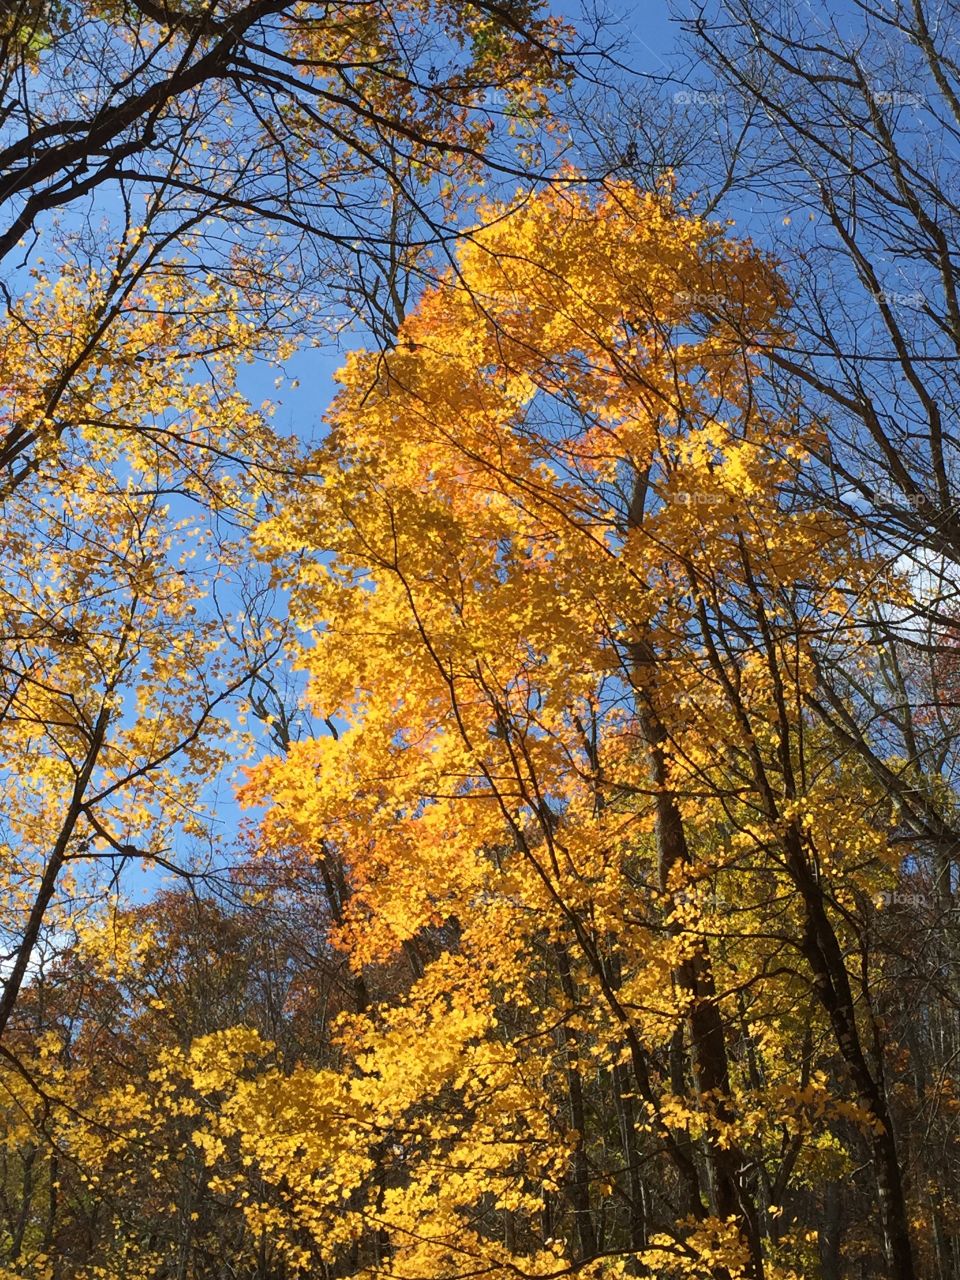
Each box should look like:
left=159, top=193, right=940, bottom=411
left=650, top=0, right=960, bottom=893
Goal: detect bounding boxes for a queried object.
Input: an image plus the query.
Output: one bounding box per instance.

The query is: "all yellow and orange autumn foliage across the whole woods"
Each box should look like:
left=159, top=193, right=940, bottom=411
left=0, top=4, right=960, bottom=1280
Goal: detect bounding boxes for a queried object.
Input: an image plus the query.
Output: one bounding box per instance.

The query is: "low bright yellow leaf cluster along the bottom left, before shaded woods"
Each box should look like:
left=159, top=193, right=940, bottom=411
left=3, top=945, right=568, bottom=1276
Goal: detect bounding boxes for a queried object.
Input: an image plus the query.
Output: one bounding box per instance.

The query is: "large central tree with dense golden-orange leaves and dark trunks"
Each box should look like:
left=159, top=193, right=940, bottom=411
left=221, top=186, right=913, bottom=1276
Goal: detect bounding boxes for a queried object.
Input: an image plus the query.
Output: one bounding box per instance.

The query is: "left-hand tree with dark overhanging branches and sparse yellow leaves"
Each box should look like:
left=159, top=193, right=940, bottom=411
left=0, top=0, right=578, bottom=1033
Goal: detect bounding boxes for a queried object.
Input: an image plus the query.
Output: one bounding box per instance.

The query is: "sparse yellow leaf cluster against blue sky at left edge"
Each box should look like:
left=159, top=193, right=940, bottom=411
left=0, top=236, right=300, bottom=952
